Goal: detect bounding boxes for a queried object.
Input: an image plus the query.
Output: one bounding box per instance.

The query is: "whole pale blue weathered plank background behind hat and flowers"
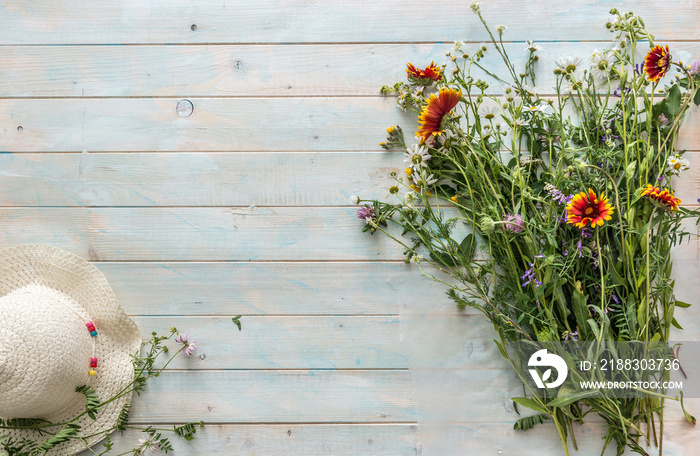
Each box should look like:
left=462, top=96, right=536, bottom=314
left=0, top=0, right=700, bottom=456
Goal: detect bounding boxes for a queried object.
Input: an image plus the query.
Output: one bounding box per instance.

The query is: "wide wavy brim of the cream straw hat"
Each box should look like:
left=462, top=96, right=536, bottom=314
left=0, top=245, right=141, bottom=455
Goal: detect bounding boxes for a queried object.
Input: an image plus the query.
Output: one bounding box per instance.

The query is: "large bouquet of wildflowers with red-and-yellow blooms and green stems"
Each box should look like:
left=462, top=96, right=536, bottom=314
left=358, top=2, right=700, bottom=455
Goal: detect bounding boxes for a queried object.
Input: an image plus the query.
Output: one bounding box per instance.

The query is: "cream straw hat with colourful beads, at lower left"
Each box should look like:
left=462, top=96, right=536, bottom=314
left=0, top=245, right=141, bottom=455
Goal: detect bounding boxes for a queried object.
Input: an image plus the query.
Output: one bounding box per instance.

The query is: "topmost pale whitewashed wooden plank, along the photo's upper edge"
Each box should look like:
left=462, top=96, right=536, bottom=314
left=0, top=0, right=700, bottom=44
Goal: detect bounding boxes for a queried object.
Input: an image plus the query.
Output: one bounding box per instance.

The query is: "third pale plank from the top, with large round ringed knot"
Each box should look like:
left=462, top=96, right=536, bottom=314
left=0, top=97, right=700, bottom=152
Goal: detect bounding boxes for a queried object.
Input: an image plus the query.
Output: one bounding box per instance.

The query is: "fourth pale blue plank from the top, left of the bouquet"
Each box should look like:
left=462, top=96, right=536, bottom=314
left=0, top=152, right=394, bottom=206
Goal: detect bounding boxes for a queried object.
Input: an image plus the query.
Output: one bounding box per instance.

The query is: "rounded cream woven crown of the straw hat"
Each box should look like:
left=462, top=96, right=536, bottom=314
left=0, top=284, right=92, bottom=418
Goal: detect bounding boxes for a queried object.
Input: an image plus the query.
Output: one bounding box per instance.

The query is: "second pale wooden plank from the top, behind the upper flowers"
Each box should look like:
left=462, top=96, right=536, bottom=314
left=0, top=42, right=700, bottom=98
